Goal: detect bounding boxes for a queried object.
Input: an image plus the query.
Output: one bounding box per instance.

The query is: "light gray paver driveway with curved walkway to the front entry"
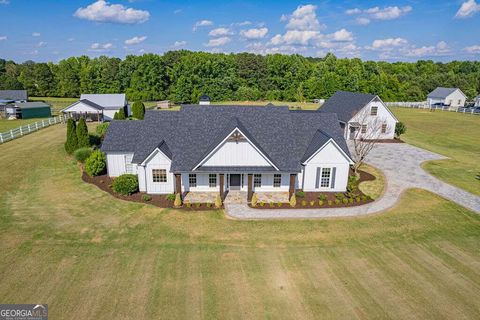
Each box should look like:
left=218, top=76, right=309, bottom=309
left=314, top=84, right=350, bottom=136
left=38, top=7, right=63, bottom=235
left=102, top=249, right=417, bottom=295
left=225, top=143, right=480, bottom=219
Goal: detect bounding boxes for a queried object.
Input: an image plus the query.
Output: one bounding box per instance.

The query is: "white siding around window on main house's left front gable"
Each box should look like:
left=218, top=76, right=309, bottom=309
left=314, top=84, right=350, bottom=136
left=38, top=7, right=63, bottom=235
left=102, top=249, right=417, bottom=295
left=144, top=151, right=175, bottom=194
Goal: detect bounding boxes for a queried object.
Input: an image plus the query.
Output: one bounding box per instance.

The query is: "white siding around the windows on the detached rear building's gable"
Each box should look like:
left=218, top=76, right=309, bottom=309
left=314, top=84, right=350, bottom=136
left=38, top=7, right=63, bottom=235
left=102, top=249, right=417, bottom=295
left=345, top=101, right=397, bottom=139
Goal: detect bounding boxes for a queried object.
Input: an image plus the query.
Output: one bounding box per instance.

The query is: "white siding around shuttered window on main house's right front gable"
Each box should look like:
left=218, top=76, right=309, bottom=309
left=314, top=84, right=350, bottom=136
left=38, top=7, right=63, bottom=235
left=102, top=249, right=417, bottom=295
left=299, top=142, right=350, bottom=192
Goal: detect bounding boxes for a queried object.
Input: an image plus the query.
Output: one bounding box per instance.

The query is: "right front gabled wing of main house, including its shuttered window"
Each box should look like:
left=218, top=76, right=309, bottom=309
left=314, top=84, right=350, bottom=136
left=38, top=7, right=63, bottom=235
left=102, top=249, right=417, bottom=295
left=298, top=140, right=352, bottom=192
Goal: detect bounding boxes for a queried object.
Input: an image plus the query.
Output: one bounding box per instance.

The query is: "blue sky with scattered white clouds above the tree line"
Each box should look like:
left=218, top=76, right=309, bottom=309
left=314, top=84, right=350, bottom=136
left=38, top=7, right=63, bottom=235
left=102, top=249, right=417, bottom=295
left=0, top=0, right=480, bottom=62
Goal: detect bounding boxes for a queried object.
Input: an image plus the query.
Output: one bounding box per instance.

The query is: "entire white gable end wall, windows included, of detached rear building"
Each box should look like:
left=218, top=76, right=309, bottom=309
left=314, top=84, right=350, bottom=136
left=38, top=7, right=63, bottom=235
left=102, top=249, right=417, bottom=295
left=346, top=97, right=398, bottom=139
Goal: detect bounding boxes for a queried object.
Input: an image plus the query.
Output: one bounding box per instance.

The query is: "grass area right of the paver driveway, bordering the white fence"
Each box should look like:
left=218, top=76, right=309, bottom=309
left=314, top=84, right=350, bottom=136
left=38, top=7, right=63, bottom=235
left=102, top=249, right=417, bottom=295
left=392, top=108, right=480, bottom=195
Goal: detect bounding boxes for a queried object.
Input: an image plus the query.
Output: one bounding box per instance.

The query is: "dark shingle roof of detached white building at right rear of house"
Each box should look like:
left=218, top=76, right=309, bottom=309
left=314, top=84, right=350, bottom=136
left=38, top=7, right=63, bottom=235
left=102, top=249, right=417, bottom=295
left=318, top=91, right=376, bottom=122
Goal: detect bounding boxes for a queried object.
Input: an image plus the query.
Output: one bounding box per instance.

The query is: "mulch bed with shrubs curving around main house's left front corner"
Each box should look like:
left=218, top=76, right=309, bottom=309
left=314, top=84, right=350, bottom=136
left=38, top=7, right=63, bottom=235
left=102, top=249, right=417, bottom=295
left=82, top=172, right=216, bottom=211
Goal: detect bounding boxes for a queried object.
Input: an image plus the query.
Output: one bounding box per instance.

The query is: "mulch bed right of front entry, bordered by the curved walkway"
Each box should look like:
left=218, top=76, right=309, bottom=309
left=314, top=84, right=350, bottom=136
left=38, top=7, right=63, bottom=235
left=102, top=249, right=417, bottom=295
left=249, top=170, right=376, bottom=209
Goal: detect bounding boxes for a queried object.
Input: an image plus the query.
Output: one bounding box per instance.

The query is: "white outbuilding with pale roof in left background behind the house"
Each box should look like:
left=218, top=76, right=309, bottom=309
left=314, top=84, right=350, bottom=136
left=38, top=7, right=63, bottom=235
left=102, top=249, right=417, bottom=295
left=62, top=93, right=130, bottom=121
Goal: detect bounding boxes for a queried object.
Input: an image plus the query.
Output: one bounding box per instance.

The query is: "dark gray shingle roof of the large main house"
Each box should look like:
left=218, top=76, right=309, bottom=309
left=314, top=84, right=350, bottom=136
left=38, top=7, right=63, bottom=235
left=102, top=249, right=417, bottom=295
left=102, top=105, right=349, bottom=172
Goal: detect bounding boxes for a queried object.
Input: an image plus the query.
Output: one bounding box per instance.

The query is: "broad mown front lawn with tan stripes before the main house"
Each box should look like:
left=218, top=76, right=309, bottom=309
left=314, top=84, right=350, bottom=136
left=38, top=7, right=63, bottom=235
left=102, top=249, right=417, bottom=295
left=0, top=125, right=480, bottom=319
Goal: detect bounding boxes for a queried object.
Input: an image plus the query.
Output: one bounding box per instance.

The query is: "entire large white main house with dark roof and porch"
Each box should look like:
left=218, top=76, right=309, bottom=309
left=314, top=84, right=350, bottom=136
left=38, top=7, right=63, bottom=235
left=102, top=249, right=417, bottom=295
left=102, top=105, right=353, bottom=200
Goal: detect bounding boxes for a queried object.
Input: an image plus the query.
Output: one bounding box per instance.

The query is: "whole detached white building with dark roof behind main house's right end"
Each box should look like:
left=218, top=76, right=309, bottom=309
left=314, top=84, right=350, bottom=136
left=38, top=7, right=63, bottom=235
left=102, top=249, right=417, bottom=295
left=319, top=91, right=398, bottom=140
